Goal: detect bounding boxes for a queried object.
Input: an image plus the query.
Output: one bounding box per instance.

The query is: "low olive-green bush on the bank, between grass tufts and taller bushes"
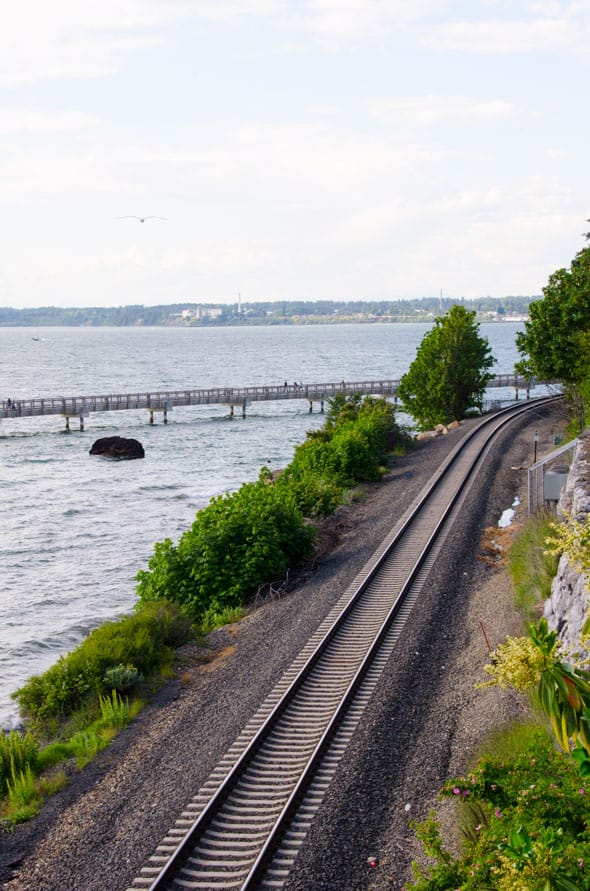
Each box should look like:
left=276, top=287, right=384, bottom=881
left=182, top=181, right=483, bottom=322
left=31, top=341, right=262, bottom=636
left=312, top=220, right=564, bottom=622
left=12, top=602, right=191, bottom=726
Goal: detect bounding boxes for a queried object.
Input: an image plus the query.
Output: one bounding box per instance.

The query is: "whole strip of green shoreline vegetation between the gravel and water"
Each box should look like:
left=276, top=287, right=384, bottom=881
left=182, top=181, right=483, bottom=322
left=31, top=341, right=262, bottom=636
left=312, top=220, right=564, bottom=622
left=0, top=395, right=411, bottom=825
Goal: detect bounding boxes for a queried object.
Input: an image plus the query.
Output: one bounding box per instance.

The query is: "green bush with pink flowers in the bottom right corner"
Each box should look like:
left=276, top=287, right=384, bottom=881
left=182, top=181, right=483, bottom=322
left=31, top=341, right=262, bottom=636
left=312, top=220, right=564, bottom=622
left=407, top=730, right=590, bottom=891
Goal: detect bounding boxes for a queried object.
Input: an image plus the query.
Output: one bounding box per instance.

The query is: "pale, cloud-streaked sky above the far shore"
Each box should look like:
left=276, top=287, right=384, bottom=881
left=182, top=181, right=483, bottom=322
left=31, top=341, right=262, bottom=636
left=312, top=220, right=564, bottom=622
left=0, top=0, right=590, bottom=307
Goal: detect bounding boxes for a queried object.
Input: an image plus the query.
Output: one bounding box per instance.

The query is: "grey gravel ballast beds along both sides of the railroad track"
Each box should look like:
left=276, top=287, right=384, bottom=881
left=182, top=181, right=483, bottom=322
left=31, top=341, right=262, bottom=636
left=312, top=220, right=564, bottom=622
left=0, top=398, right=564, bottom=891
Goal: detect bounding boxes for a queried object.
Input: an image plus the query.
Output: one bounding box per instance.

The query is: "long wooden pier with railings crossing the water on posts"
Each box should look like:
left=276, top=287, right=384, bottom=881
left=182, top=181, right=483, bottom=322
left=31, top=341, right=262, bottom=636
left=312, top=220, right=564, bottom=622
left=0, top=374, right=535, bottom=430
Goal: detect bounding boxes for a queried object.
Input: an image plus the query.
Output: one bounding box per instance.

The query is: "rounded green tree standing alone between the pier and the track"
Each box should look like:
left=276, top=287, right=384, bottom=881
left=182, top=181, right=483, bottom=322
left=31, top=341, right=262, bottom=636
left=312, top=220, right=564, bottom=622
left=398, top=305, right=496, bottom=430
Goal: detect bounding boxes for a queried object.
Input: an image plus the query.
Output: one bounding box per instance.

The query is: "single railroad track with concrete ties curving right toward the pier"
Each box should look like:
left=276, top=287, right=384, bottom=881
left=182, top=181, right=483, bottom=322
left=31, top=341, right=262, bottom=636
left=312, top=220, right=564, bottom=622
left=128, top=397, right=559, bottom=891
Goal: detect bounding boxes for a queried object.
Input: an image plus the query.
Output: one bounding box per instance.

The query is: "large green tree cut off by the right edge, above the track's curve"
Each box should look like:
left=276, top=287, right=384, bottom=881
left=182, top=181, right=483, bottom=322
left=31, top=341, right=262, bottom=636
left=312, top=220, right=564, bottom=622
left=516, top=233, right=590, bottom=433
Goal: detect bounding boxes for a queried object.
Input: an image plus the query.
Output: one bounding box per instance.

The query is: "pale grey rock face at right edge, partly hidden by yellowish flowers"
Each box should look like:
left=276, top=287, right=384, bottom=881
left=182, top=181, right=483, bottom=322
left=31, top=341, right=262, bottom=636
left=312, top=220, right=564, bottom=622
left=544, top=430, right=590, bottom=651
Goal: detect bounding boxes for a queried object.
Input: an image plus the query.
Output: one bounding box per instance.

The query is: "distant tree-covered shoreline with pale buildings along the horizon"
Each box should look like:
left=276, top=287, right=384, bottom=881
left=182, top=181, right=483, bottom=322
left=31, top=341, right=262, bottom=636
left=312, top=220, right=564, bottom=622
left=0, top=296, right=539, bottom=327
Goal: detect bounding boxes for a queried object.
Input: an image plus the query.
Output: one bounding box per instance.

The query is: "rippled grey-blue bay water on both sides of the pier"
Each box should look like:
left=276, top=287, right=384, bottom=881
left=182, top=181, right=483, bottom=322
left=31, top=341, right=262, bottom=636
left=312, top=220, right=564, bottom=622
left=0, top=323, right=521, bottom=727
